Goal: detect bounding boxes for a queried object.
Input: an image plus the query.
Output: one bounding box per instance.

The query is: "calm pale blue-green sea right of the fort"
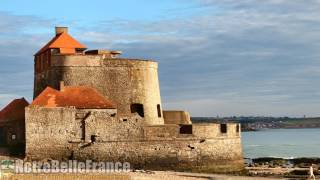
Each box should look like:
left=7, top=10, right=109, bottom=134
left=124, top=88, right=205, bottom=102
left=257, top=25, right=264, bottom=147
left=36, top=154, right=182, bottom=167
left=242, top=129, right=320, bottom=158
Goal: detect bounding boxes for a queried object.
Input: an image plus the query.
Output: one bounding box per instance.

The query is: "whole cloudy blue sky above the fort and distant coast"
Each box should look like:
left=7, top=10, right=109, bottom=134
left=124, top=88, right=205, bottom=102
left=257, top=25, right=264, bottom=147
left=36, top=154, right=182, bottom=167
left=0, top=0, right=320, bottom=116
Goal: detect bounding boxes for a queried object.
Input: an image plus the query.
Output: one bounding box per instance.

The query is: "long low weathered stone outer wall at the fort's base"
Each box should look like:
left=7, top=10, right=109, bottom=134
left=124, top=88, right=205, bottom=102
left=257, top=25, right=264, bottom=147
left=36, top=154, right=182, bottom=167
left=26, top=106, right=244, bottom=172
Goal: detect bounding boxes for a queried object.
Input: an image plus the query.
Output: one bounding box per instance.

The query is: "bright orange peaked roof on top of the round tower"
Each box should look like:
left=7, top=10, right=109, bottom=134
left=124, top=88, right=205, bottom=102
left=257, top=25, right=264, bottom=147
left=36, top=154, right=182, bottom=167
left=36, top=32, right=86, bottom=55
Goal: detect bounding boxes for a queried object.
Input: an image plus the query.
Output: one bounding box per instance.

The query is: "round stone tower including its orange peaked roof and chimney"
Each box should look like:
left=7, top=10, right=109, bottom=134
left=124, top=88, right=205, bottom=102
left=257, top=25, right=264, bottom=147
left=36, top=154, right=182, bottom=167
left=34, top=27, right=164, bottom=125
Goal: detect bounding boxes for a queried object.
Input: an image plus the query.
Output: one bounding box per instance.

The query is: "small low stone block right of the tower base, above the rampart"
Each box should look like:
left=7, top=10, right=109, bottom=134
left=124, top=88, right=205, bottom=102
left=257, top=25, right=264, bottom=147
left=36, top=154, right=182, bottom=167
left=163, top=111, right=192, bottom=124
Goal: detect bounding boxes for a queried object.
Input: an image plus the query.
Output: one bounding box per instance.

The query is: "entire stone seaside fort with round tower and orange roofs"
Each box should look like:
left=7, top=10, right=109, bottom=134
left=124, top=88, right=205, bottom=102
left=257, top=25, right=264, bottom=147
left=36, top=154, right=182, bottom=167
left=0, top=27, right=244, bottom=172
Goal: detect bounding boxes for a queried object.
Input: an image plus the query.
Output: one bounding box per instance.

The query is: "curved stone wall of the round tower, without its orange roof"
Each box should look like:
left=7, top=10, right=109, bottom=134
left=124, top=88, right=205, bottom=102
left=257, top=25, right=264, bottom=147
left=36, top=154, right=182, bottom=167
left=34, top=55, right=164, bottom=125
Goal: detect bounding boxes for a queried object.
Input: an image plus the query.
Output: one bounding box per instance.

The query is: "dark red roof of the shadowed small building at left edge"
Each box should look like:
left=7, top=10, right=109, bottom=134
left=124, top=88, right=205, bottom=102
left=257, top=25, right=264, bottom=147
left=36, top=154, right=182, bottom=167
left=0, top=98, right=29, bottom=121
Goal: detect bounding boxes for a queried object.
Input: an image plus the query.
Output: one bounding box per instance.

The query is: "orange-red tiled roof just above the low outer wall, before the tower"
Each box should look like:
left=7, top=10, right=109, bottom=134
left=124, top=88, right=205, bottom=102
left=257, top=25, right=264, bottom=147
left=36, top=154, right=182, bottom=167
left=31, top=86, right=115, bottom=109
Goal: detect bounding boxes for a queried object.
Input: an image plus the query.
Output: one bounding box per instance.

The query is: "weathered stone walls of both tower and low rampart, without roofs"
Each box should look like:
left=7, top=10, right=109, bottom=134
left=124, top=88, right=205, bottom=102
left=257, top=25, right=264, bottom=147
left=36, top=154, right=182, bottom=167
left=30, top=55, right=243, bottom=172
